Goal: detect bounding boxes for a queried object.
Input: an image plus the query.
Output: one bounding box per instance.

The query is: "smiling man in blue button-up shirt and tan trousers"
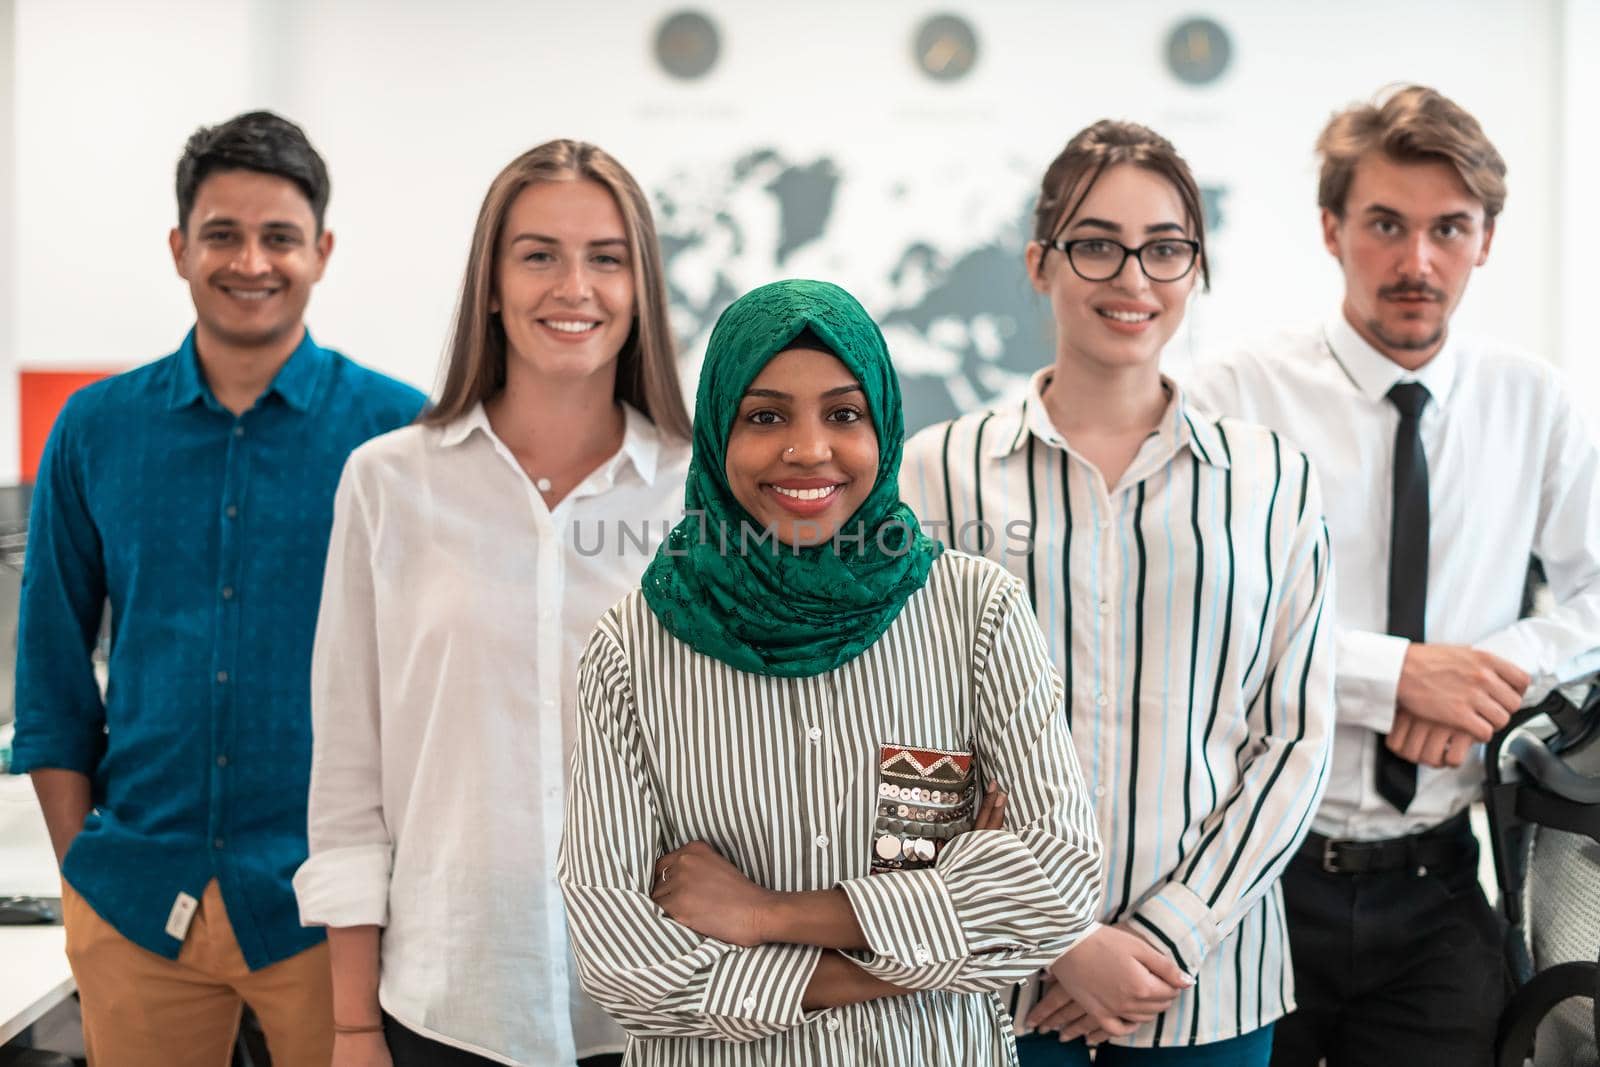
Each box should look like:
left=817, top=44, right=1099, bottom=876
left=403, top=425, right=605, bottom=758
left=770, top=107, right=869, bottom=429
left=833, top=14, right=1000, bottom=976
left=14, top=112, right=424, bottom=1067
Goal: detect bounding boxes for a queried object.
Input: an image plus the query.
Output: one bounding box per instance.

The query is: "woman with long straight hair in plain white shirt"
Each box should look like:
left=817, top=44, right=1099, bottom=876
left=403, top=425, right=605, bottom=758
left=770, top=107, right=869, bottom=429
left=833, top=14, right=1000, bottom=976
left=294, top=141, right=690, bottom=1067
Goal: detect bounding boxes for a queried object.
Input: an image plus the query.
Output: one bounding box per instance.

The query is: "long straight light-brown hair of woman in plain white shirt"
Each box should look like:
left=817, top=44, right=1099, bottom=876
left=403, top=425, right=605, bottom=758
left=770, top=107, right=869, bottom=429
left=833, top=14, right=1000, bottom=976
left=421, top=139, right=691, bottom=440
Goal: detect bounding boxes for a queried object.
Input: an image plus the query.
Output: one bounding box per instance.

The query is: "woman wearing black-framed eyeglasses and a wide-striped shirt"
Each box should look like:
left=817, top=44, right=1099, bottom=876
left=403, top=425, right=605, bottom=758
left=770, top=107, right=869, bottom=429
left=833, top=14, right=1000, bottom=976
left=901, top=122, right=1333, bottom=1067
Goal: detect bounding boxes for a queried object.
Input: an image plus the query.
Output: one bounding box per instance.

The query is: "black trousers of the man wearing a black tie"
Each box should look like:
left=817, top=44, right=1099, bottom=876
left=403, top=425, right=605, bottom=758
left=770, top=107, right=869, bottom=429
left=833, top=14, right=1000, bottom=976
left=1272, top=832, right=1510, bottom=1067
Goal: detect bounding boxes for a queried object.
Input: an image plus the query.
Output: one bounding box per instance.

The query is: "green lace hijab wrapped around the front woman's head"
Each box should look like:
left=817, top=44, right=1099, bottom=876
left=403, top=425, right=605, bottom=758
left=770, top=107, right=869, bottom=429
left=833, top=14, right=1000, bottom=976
left=643, top=280, right=941, bottom=677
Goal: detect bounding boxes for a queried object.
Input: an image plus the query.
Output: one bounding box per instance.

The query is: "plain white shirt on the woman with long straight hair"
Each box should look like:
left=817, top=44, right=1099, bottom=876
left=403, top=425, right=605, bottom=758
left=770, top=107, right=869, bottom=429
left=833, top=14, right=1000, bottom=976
left=294, top=406, right=688, bottom=1065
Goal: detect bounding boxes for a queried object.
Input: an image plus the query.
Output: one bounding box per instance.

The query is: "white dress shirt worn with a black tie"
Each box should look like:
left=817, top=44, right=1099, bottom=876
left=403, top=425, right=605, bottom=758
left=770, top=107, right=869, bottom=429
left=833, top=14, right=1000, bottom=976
left=1187, top=315, right=1600, bottom=840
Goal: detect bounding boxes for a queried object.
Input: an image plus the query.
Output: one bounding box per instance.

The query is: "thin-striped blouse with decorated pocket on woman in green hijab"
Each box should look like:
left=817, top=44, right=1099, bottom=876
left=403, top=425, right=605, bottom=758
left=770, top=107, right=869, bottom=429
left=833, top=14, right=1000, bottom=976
left=560, top=552, right=1101, bottom=1067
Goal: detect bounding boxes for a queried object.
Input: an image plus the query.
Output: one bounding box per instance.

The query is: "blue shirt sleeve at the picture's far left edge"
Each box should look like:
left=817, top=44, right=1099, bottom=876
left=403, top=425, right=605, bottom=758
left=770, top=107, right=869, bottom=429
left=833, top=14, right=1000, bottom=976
left=11, top=402, right=106, bottom=774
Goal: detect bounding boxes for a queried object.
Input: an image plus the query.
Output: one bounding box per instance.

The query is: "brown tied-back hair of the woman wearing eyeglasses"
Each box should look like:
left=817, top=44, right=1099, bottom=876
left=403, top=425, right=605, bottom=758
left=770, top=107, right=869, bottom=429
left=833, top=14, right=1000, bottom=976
left=1034, top=118, right=1211, bottom=290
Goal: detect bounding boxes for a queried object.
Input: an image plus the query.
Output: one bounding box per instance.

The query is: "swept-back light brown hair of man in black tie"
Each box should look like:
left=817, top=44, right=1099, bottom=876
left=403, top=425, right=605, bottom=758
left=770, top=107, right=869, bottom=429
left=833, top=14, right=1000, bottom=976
left=1317, top=85, right=1506, bottom=221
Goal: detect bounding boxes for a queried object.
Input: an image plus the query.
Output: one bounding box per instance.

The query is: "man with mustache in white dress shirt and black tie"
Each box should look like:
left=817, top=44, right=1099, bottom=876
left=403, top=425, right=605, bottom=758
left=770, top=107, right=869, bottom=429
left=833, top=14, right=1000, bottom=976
left=1190, top=86, right=1600, bottom=1067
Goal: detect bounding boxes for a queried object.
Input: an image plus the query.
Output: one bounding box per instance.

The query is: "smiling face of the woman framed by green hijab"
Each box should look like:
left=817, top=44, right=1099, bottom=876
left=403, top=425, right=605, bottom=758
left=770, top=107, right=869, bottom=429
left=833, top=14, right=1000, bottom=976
left=726, top=349, right=878, bottom=545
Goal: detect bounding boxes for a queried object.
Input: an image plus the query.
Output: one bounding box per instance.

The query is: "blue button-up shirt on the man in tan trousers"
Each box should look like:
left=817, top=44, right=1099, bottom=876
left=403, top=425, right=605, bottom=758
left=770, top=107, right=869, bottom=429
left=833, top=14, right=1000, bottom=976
left=13, top=333, right=424, bottom=969
